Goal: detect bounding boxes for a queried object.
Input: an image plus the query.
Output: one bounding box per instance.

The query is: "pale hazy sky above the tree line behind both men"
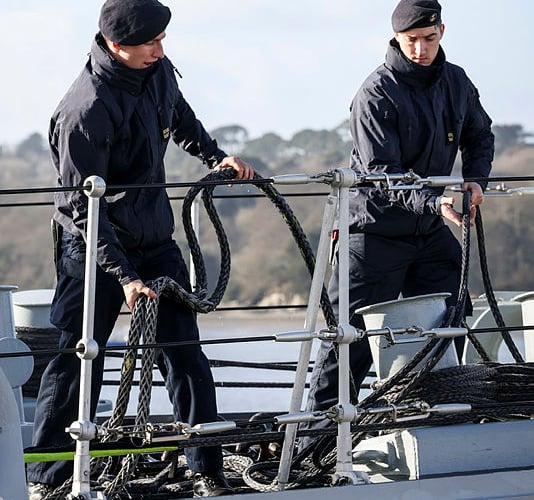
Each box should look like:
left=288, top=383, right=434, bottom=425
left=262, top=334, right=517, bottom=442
left=0, top=0, right=534, bottom=146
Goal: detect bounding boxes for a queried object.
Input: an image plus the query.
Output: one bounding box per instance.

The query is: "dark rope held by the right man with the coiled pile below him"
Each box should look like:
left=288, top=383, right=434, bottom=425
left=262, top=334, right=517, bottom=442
left=244, top=192, right=534, bottom=491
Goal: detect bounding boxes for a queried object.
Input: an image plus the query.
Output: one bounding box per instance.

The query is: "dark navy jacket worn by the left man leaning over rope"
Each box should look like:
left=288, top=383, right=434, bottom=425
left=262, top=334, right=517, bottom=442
left=49, top=34, right=226, bottom=284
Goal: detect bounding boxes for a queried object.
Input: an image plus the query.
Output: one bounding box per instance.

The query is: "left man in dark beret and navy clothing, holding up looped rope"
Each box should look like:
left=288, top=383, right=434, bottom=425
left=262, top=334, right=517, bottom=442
left=27, top=0, right=254, bottom=500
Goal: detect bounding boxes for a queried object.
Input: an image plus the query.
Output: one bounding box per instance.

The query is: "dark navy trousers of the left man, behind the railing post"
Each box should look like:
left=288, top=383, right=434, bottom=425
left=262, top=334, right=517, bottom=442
left=27, top=233, right=222, bottom=486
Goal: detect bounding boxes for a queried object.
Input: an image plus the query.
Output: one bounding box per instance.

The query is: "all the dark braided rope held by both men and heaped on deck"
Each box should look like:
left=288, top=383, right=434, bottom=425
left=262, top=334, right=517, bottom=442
left=38, top=175, right=534, bottom=499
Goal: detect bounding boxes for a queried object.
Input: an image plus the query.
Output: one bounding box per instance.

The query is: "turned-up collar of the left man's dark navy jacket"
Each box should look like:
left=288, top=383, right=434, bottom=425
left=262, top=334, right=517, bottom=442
left=90, top=33, right=159, bottom=95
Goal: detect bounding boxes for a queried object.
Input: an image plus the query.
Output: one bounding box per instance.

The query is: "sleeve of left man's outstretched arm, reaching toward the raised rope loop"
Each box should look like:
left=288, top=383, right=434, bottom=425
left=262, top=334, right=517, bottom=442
left=172, top=91, right=227, bottom=168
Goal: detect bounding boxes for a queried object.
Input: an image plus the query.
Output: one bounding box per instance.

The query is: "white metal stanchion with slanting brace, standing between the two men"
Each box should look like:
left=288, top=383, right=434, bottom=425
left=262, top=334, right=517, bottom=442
left=272, top=168, right=463, bottom=490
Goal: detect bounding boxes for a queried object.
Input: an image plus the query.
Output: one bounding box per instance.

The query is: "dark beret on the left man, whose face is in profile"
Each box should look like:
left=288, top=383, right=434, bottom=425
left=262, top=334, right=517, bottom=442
left=98, top=0, right=171, bottom=45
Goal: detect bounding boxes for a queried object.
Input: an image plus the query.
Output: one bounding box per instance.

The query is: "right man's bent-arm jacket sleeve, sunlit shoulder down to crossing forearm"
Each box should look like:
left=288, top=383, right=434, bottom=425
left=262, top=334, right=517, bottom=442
left=350, top=87, right=443, bottom=215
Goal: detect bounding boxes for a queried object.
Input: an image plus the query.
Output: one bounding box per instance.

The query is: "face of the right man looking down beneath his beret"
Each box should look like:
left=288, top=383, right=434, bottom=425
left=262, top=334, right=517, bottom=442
left=395, top=24, right=445, bottom=66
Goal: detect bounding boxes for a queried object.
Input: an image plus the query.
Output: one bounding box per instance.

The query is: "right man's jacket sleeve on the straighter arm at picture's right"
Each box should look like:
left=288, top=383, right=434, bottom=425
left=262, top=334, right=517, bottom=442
left=460, top=80, right=495, bottom=189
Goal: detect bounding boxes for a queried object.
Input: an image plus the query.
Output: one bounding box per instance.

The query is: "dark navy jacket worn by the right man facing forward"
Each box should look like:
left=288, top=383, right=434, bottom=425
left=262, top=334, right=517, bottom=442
left=350, top=40, right=494, bottom=237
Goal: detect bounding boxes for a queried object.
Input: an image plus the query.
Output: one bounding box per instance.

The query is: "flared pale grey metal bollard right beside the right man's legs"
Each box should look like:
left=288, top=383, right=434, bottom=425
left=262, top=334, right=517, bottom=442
left=356, top=293, right=458, bottom=380
